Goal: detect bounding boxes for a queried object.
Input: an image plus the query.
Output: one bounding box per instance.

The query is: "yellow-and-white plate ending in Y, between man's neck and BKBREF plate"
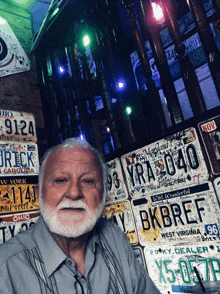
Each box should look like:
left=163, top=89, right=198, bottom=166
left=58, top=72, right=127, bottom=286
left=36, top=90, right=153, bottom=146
left=102, top=201, right=138, bottom=244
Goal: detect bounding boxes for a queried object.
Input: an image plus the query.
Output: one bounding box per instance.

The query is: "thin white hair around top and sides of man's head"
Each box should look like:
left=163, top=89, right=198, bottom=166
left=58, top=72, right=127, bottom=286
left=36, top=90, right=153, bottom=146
left=38, top=138, right=108, bottom=199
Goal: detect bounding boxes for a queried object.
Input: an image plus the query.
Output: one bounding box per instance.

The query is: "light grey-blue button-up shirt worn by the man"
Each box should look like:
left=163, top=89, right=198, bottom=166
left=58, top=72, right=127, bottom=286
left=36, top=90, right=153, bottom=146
left=0, top=217, right=160, bottom=294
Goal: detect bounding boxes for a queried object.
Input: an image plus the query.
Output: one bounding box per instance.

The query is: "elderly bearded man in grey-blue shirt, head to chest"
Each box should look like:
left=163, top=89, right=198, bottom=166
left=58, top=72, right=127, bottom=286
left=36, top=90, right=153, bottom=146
left=0, top=139, right=159, bottom=294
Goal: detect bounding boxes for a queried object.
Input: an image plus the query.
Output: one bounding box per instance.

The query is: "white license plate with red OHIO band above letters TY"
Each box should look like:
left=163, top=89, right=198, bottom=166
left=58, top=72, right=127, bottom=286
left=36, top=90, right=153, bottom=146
left=0, top=212, right=39, bottom=244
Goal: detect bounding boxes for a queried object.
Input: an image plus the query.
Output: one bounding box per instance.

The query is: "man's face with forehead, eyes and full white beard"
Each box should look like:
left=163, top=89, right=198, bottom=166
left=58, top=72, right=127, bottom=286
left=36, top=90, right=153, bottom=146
left=40, top=146, right=104, bottom=238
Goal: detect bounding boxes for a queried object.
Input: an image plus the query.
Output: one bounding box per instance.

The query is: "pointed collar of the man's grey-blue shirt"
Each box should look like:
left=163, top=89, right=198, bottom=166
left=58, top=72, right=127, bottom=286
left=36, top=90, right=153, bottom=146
left=34, top=215, right=101, bottom=277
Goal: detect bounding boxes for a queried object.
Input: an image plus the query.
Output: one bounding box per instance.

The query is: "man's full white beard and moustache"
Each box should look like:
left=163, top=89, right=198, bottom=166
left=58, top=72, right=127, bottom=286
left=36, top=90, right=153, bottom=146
left=39, top=193, right=105, bottom=238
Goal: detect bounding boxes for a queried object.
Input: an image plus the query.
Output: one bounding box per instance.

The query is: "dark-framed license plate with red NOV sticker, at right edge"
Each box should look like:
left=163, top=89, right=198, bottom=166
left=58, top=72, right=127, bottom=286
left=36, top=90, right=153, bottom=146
left=198, top=115, right=220, bottom=175
